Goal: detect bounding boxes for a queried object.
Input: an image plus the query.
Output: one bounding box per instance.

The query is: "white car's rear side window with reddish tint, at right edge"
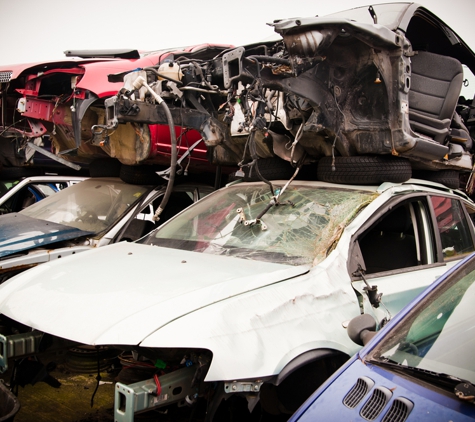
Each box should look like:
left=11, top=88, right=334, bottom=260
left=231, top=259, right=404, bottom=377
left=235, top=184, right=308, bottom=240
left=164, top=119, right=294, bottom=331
left=431, top=196, right=474, bottom=260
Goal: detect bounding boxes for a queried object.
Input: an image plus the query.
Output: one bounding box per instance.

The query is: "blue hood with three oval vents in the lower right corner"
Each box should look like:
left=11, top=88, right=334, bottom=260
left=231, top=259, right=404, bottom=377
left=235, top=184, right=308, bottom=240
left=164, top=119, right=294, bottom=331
left=291, top=356, right=475, bottom=422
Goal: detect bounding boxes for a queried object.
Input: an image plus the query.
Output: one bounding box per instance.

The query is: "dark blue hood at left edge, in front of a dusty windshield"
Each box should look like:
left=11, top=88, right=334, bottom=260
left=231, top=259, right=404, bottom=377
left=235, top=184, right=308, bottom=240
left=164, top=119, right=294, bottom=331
left=0, top=213, right=91, bottom=258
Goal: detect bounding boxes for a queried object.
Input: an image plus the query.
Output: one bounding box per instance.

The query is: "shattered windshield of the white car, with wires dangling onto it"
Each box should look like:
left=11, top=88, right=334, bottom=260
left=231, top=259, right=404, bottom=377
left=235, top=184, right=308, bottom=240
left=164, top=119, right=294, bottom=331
left=141, top=183, right=375, bottom=265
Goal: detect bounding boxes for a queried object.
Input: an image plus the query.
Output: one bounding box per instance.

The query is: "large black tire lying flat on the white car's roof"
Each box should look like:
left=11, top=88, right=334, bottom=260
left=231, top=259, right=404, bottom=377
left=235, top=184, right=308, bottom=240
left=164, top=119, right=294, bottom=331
left=317, top=155, right=412, bottom=185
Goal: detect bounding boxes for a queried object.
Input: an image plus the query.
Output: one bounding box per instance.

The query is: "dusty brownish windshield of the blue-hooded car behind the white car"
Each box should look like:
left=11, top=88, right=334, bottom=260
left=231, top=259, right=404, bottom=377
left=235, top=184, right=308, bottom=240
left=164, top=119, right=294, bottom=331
left=20, top=179, right=150, bottom=233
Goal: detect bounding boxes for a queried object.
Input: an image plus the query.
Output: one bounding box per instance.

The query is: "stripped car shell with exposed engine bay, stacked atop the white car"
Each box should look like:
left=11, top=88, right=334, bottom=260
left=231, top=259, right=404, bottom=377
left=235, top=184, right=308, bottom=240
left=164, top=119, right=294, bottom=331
left=103, top=3, right=475, bottom=187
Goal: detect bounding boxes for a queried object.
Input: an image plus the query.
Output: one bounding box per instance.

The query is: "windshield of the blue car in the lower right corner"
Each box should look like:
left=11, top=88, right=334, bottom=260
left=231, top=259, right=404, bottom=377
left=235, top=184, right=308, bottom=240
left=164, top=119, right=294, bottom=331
left=369, top=260, right=475, bottom=383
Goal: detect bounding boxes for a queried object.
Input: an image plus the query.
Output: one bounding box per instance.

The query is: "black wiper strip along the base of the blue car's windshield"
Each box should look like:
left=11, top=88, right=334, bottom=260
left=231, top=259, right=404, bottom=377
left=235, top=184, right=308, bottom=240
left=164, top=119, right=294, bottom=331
left=366, top=358, right=475, bottom=403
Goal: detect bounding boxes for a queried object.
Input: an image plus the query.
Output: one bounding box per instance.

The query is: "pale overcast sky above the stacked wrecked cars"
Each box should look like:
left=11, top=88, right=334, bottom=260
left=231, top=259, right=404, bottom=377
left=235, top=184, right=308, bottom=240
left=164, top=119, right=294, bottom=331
left=0, top=0, right=475, bottom=65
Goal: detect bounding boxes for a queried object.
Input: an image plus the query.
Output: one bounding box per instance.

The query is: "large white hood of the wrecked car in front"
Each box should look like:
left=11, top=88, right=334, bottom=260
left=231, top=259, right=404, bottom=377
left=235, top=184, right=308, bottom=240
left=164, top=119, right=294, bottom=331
left=0, top=242, right=308, bottom=345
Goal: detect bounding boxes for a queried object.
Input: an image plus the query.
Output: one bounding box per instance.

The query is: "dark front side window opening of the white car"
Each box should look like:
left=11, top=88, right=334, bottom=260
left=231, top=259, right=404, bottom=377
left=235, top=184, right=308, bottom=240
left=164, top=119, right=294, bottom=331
left=358, top=198, right=436, bottom=274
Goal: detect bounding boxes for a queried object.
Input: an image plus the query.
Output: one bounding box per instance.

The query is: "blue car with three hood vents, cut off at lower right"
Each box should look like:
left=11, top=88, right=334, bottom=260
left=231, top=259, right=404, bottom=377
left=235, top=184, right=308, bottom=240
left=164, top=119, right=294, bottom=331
left=289, top=254, right=475, bottom=422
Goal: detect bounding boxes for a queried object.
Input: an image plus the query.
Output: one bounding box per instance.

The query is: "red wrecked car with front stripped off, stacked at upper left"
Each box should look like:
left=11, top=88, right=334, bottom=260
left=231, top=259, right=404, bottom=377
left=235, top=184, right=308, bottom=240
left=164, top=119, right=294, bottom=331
left=0, top=44, right=231, bottom=168
